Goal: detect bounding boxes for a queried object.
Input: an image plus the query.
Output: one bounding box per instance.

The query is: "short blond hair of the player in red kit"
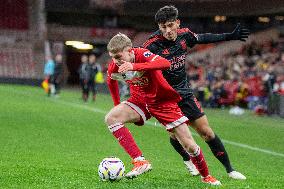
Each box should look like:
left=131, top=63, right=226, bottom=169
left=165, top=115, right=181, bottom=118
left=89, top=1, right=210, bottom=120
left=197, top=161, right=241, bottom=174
left=107, top=33, right=132, bottom=53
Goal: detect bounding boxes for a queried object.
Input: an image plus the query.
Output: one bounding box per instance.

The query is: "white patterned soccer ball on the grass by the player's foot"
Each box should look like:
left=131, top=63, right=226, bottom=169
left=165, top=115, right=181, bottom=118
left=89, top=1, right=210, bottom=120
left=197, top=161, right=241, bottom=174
left=98, top=157, right=125, bottom=181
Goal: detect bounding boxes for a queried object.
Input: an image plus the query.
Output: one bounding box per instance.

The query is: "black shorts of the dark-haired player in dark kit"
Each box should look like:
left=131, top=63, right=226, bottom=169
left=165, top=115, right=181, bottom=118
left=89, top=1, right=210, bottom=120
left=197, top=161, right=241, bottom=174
left=178, top=96, right=205, bottom=123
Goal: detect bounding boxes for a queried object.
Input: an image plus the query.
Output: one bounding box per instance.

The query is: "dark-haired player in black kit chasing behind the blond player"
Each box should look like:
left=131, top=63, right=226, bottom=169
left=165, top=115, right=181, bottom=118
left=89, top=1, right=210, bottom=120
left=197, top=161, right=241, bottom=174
left=143, top=6, right=249, bottom=180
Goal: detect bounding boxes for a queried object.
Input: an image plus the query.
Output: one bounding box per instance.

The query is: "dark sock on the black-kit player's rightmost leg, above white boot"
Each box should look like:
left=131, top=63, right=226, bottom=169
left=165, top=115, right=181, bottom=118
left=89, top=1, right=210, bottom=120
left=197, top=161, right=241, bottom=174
left=206, top=134, right=234, bottom=173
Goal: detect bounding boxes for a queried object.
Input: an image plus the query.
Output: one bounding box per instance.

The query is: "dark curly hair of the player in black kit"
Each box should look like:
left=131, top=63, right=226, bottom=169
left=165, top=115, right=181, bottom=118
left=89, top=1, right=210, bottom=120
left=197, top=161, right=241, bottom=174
left=155, top=5, right=178, bottom=24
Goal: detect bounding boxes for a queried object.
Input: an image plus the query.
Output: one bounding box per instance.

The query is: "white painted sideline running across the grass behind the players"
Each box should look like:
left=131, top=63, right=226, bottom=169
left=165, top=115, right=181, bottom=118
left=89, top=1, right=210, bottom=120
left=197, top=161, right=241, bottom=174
left=54, top=99, right=284, bottom=157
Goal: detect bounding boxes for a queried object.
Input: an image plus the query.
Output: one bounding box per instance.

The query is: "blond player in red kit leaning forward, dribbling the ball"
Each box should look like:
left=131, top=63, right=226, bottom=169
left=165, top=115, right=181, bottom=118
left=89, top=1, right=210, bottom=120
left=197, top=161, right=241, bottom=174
left=105, top=33, right=221, bottom=185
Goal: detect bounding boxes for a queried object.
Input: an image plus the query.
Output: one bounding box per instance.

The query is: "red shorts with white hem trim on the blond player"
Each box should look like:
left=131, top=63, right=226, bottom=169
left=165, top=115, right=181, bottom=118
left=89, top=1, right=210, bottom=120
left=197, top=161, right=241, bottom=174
left=122, top=98, right=188, bottom=131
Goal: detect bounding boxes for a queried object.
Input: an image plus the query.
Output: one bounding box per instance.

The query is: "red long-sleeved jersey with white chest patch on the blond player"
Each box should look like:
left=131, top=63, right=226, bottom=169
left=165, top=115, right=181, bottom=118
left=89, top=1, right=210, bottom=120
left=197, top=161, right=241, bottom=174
left=107, top=48, right=181, bottom=105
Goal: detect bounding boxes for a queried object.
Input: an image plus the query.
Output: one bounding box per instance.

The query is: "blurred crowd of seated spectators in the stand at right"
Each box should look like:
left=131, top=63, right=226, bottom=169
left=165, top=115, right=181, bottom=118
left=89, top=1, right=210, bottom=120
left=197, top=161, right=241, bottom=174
left=187, top=41, right=284, bottom=109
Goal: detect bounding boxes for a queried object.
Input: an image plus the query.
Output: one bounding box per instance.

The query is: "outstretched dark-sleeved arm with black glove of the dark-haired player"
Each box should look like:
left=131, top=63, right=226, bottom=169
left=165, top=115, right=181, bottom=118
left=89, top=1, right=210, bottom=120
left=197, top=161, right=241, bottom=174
left=197, top=23, right=250, bottom=44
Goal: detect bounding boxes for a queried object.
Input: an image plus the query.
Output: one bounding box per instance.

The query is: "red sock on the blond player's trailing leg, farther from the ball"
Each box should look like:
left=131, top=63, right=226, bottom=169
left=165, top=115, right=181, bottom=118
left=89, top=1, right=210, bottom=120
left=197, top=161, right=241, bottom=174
left=189, top=146, right=209, bottom=177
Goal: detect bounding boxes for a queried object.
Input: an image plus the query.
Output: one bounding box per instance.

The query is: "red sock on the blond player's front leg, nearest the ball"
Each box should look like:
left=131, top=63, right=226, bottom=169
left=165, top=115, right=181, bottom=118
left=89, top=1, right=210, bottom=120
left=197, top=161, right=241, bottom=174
left=109, top=123, right=142, bottom=159
